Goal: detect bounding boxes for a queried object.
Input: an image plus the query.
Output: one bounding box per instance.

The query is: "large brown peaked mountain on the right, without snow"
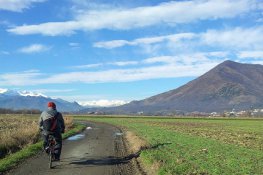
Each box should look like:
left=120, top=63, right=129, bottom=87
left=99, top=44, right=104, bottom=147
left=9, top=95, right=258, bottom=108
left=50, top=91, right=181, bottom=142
left=114, top=61, right=263, bottom=113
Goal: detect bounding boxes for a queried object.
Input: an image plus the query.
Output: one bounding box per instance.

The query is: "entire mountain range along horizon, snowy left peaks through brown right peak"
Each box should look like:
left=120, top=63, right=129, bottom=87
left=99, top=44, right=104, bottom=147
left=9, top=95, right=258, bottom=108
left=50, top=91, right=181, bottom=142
left=0, top=61, right=263, bottom=114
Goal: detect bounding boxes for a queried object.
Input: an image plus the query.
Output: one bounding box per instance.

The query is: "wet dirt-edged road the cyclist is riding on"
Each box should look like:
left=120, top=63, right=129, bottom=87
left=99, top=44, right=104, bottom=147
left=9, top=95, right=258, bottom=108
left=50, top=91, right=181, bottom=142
left=7, top=123, right=141, bottom=175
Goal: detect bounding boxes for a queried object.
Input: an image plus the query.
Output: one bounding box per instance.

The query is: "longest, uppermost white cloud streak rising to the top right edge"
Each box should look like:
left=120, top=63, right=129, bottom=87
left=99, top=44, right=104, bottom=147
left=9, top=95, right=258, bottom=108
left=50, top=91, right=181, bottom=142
left=8, top=0, right=258, bottom=36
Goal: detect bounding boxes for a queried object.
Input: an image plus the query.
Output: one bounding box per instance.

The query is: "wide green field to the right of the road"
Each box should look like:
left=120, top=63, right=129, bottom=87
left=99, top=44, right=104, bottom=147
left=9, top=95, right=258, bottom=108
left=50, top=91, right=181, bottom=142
left=76, top=116, right=263, bottom=175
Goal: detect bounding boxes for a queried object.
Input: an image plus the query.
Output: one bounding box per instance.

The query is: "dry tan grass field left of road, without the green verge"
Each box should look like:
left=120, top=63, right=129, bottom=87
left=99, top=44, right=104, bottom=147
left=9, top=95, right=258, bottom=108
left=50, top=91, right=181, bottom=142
left=0, top=115, right=73, bottom=158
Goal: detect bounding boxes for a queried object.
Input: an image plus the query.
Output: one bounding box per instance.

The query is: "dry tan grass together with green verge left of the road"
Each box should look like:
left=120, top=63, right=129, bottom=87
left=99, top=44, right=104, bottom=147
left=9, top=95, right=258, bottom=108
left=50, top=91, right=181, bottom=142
left=0, top=115, right=85, bottom=174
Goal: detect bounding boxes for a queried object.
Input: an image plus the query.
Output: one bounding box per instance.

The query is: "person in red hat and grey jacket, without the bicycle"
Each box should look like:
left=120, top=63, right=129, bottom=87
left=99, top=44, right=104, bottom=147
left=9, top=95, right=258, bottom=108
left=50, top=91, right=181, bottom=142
left=39, top=102, right=65, bottom=161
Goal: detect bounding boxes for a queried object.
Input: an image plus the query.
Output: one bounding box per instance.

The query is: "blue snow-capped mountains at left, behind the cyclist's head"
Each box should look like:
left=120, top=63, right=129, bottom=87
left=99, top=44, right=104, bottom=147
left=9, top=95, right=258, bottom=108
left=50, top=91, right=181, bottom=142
left=0, top=89, right=83, bottom=112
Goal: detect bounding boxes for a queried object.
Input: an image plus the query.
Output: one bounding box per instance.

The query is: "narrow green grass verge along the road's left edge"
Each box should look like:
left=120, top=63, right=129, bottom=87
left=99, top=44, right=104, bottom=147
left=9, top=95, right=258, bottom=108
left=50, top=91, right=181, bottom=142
left=0, top=124, right=86, bottom=174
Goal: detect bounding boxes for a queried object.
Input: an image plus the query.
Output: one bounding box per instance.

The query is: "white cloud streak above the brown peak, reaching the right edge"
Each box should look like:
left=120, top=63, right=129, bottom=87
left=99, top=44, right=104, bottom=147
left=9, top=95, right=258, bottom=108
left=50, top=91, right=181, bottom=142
left=93, top=26, right=263, bottom=51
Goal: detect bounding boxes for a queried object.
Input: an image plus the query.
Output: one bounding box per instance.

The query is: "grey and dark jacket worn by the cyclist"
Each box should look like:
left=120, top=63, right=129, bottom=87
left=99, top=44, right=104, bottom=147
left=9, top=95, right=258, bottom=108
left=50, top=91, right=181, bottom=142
left=39, top=108, right=65, bottom=135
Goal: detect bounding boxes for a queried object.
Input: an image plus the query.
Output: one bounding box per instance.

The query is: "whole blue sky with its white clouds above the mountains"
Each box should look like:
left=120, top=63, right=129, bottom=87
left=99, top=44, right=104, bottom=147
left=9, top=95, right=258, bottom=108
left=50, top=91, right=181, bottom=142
left=0, top=0, right=263, bottom=105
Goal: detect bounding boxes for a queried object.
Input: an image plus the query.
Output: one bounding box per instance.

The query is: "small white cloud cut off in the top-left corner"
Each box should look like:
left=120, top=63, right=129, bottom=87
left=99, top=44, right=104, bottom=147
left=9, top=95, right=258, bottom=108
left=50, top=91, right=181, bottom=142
left=0, top=0, right=46, bottom=12
